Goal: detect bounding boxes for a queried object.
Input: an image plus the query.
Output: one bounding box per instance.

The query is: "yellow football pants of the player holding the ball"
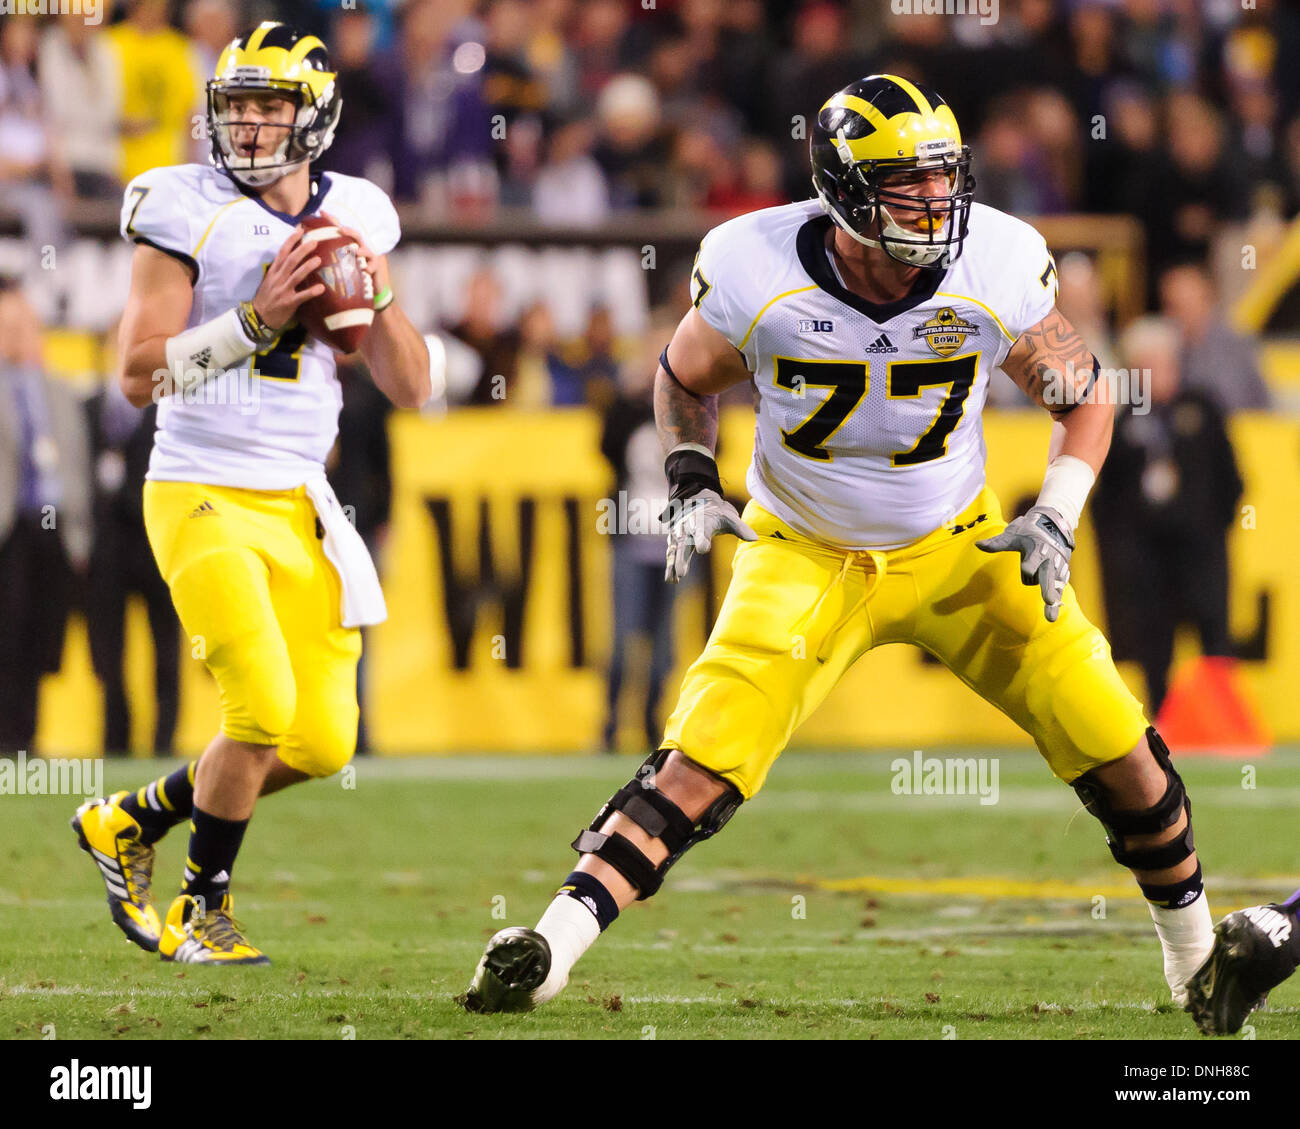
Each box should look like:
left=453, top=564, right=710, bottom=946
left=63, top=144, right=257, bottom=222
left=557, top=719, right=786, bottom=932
left=144, top=481, right=361, bottom=777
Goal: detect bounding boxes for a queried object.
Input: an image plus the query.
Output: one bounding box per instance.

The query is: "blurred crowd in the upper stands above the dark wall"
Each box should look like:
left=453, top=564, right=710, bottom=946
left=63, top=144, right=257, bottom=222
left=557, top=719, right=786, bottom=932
left=0, top=0, right=1300, bottom=247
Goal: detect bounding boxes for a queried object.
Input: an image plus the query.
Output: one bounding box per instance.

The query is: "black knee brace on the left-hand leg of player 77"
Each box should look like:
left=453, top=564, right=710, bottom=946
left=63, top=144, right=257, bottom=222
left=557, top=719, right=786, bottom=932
left=572, top=749, right=744, bottom=901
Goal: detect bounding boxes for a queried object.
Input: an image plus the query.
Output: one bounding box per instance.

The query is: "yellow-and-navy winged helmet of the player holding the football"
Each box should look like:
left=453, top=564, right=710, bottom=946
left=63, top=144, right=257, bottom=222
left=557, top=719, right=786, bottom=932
left=208, top=21, right=343, bottom=187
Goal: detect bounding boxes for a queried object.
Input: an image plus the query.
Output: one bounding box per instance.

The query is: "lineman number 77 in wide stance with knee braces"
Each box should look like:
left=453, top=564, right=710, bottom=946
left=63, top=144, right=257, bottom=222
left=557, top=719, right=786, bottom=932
left=464, top=74, right=1213, bottom=1012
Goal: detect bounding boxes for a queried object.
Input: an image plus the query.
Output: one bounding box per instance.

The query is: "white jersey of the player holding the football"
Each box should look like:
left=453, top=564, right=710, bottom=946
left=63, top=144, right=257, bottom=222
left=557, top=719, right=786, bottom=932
left=122, top=164, right=400, bottom=490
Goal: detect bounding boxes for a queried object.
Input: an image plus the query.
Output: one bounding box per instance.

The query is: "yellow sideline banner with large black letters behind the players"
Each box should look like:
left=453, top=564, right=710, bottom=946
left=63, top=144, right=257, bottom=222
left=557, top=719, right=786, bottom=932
left=40, top=408, right=1300, bottom=754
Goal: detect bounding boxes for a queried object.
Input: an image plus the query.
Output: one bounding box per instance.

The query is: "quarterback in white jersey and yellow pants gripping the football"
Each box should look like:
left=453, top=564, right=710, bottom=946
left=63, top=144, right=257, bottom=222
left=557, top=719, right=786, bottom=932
left=73, top=22, right=430, bottom=964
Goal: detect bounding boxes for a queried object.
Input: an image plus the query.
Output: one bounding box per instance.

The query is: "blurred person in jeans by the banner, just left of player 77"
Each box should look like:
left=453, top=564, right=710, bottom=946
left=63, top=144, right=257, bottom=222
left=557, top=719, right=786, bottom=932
left=601, top=319, right=676, bottom=753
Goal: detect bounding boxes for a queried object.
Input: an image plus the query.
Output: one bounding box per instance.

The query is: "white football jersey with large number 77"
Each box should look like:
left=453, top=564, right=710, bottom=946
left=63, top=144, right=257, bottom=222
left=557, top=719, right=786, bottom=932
left=692, top=200, right=1057, bottom=549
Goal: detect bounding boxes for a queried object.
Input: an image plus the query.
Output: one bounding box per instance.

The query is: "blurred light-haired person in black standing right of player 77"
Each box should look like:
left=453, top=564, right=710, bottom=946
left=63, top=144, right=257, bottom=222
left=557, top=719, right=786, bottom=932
left=1092, top=317, right=1242, bottom=717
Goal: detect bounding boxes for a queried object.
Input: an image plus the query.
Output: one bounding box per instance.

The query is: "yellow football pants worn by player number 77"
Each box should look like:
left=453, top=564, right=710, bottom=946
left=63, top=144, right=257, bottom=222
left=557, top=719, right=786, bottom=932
left=664, top=488, right=1147, bottom=799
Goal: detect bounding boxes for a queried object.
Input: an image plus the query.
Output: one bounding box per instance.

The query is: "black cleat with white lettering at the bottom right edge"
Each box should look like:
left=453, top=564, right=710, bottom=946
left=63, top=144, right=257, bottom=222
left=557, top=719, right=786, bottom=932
left=1186, top=904, right=1300, bottom=1035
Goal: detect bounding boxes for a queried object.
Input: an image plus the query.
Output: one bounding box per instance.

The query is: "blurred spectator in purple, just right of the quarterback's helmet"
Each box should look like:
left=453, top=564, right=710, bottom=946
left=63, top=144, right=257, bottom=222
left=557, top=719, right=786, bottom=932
left=374, top=0, right=497, bottom=213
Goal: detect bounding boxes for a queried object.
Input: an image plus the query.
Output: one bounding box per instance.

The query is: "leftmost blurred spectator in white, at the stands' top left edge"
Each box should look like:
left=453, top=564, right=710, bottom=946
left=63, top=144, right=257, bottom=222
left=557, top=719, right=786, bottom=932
left=0, top=16, right=73, bottom=251
